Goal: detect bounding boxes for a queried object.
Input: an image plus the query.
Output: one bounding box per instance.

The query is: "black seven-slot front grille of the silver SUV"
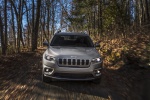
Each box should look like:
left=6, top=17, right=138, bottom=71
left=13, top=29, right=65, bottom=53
left=58, top=58, right=90, bottom=67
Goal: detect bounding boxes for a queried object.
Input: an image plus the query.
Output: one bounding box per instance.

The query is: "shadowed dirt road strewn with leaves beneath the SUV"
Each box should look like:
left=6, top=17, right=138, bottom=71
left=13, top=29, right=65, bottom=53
left=0, top=53, right=150, bottom=100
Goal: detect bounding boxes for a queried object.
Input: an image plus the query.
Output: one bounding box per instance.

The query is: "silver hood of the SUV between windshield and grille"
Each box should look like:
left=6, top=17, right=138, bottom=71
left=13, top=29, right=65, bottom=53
left=48, top=47, right=100, bottom=59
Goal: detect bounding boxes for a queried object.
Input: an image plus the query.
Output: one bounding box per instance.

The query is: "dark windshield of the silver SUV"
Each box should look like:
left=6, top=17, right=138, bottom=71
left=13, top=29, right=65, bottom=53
left=50, top=35, right=94, bottom=47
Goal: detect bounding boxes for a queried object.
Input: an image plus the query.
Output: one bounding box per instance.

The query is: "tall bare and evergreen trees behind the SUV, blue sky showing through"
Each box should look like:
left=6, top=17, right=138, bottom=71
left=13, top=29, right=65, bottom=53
left=0, top=0, right=150, bottom=55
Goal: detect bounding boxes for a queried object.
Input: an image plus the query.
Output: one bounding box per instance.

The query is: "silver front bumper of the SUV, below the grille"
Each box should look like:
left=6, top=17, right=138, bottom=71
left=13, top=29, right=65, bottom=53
left=42, top=61, right=102, bottom=80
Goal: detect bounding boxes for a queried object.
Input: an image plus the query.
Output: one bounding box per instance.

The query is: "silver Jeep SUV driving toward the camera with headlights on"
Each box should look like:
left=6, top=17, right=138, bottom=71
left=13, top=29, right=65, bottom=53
left=42, top=32, right=102, bottom=83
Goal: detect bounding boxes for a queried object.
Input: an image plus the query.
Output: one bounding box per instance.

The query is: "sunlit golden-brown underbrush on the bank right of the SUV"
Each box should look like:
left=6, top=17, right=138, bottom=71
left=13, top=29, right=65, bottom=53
left=97, top=34, right=150, bottom=69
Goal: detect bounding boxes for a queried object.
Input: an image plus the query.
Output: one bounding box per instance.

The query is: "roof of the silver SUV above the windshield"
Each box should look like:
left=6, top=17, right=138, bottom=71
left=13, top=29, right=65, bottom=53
left=54, top=32, right=89, bottom=36
